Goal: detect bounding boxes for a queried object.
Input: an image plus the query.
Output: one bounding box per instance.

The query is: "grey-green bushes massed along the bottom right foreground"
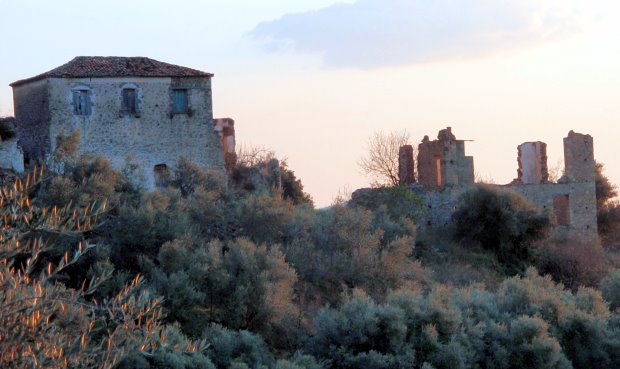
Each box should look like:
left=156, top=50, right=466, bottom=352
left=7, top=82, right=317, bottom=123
left=305, top=270, right=620, bottom=369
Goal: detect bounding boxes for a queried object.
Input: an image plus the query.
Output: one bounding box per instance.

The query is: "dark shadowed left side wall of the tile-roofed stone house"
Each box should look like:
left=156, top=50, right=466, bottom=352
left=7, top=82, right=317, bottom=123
left=13, top=79, right=51, bottom=162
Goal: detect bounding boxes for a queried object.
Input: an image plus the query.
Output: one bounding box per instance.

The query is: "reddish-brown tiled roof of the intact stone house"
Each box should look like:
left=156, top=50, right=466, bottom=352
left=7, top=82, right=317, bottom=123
left=10, top=56, right=213, bottom=87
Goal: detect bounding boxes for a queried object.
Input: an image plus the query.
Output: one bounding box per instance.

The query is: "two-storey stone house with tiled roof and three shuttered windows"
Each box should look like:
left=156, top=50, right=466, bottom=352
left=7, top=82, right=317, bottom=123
left=11, top=56, right=234, bottom=188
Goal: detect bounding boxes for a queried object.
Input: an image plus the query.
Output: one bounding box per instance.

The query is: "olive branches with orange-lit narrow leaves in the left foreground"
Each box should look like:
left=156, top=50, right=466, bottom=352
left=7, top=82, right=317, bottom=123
left=0, top=173, right=204, bottom=368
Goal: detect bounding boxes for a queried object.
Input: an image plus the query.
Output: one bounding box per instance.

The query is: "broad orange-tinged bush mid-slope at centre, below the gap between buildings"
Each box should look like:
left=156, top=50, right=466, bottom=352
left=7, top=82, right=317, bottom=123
left=285, top=205, right=430, bottom=305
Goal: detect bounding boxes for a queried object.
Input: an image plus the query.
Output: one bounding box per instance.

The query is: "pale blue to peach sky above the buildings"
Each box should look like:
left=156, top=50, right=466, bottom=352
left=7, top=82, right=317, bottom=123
left=0, top=0, right=620, bottom=206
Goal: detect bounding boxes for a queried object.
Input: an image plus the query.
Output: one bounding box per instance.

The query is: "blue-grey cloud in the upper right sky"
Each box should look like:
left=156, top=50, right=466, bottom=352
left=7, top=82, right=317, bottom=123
left=249, top=0, right=579, bottom=68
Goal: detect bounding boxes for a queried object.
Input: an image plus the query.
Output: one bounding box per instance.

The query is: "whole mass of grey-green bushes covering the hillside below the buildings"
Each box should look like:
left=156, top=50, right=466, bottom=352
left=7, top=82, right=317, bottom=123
left=7, top=150, right=620, bottom=369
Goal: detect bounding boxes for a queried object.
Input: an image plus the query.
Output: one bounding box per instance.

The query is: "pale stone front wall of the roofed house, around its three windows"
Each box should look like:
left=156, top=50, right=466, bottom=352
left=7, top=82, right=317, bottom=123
left=46, top=77, right=224, bottom=188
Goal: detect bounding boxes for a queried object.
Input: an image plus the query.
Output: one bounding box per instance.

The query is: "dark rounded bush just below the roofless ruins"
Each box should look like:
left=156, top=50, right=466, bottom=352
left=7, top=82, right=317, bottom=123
left=453, top=185, right=550, bottom=265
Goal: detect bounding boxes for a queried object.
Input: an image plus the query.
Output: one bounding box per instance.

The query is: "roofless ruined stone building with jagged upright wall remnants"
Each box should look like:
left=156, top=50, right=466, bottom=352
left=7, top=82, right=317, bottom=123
left=399, top=127, right=598, bottom=240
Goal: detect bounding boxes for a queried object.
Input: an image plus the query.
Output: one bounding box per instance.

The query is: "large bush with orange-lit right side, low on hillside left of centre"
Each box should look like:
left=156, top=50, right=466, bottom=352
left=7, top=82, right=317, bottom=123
left=141, top=239, right=297, bottom=346
